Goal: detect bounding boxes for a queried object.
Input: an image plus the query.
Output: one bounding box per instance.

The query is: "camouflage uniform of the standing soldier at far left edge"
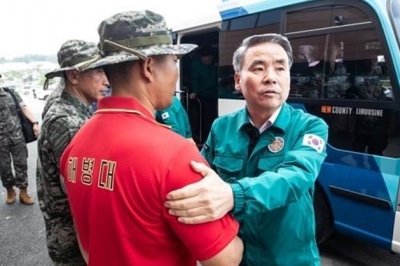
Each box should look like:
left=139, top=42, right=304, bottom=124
left=0, top=88, right=28, bottom=188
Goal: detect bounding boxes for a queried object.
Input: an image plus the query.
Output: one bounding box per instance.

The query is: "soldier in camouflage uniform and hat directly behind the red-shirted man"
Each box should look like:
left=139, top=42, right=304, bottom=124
left=37, top=40, right=108, bottom=265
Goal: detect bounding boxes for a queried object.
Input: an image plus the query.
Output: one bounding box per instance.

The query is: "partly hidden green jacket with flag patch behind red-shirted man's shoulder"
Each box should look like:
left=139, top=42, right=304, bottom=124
left=155, top=97, right=192, bottom=138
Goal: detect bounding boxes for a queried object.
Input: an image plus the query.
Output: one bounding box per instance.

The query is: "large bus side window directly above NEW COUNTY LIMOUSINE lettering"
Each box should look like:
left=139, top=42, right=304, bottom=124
left=290, top=30, right=394, bottom=101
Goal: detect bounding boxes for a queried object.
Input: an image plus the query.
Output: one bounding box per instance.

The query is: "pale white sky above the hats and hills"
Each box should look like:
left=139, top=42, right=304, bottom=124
left=0, top=0, right=221, bottom=59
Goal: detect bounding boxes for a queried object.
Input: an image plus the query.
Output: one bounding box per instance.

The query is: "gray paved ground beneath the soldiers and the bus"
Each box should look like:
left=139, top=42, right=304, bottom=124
left=0, top=94, right=400, bottom=266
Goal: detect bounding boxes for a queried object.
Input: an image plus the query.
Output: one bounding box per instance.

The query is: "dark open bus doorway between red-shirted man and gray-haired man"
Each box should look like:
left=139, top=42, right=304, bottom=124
left=180, top=30, right=219, bottom=147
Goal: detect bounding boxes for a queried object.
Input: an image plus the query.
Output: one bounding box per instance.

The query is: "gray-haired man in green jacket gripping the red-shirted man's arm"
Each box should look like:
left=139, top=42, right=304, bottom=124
left=165, top=34, right=328, bottom=266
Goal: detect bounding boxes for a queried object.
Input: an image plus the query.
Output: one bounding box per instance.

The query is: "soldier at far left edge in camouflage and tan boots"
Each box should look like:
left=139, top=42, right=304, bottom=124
left=0, top=72, right=39, bottom=205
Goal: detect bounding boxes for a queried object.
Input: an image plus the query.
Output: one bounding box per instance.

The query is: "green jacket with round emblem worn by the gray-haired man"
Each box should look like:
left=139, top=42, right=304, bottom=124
left=202, top=104, right=328, bottom=266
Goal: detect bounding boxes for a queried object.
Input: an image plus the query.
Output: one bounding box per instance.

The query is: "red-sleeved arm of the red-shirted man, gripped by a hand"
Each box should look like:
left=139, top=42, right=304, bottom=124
left=163, top=142, right=243, bottom=266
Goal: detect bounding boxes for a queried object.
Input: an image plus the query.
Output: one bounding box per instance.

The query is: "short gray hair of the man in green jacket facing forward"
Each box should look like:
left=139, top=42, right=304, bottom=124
left=232, top=33, right=293, bottom=72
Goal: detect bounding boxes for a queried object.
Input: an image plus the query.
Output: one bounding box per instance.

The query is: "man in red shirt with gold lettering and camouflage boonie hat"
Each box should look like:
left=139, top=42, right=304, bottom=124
left=60, top=11, right=243, bottom=266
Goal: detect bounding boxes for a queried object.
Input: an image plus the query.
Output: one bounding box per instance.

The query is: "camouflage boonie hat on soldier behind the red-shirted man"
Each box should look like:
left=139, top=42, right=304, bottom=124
left=45, top=40, right=101, bottom=79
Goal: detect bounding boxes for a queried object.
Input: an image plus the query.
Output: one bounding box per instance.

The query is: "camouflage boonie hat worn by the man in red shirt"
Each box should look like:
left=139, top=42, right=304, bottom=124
left=88, top=10, right=197, bottom=67
